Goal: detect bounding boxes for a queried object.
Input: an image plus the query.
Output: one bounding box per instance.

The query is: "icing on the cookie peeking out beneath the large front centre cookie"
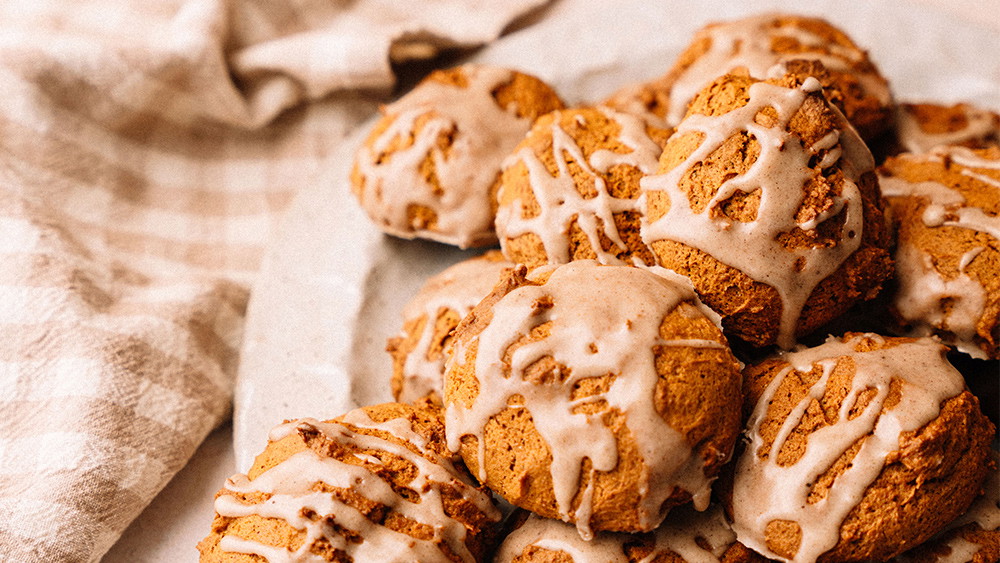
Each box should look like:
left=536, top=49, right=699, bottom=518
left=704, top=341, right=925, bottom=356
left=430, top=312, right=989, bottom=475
left=494, top=506, right=736, bottom=563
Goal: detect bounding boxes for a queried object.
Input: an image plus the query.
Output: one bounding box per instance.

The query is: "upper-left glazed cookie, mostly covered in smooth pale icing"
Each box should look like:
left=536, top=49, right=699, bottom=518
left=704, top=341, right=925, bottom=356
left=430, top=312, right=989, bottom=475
left=351, top=65, right=563, bottom=248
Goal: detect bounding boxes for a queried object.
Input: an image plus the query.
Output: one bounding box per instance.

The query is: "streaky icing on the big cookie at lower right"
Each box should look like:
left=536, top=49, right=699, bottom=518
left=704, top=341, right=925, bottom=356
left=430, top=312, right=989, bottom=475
left=733, top=334, right=965, bottom=563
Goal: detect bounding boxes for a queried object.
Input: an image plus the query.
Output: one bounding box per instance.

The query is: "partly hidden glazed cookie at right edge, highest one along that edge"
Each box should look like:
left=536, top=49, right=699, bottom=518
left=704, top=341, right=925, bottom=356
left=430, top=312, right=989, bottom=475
left=892, top=104, right=1000, bottom=153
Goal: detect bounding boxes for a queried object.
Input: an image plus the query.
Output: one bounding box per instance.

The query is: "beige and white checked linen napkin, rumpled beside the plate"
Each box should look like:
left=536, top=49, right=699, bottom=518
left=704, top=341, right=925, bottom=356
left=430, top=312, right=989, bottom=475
left=0, top=0, right=540, bottom=562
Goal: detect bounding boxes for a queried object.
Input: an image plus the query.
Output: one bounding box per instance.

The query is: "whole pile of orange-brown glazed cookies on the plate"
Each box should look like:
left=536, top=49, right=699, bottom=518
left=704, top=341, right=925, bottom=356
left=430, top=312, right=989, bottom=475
left=199, top=14, right=1000, bottom=563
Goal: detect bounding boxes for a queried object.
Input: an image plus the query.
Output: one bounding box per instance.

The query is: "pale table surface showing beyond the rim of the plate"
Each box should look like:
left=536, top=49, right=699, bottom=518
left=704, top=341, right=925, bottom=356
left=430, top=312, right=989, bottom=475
left=103, top=0, right=1000, bottom=563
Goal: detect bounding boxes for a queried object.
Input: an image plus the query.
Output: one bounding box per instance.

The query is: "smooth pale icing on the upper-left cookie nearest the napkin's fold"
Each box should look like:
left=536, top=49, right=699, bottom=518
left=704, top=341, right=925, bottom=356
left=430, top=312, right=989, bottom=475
left=355, top=65, right=531, bottom=248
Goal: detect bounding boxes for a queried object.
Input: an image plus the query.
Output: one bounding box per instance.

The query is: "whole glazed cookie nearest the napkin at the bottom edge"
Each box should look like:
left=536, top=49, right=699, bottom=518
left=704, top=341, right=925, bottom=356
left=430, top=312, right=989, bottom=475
left=198, top=403, right=500, bottom=563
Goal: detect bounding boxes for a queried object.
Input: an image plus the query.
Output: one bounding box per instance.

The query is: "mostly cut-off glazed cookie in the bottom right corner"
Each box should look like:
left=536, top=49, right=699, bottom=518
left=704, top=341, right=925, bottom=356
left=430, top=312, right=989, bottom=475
left=893, top=462, right=1000, bottom=563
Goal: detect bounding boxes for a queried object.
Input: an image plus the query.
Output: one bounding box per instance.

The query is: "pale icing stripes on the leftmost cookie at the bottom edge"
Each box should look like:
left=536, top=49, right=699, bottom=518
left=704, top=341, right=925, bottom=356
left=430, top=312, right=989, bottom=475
left=215, top=412, right=500, bottom=563
